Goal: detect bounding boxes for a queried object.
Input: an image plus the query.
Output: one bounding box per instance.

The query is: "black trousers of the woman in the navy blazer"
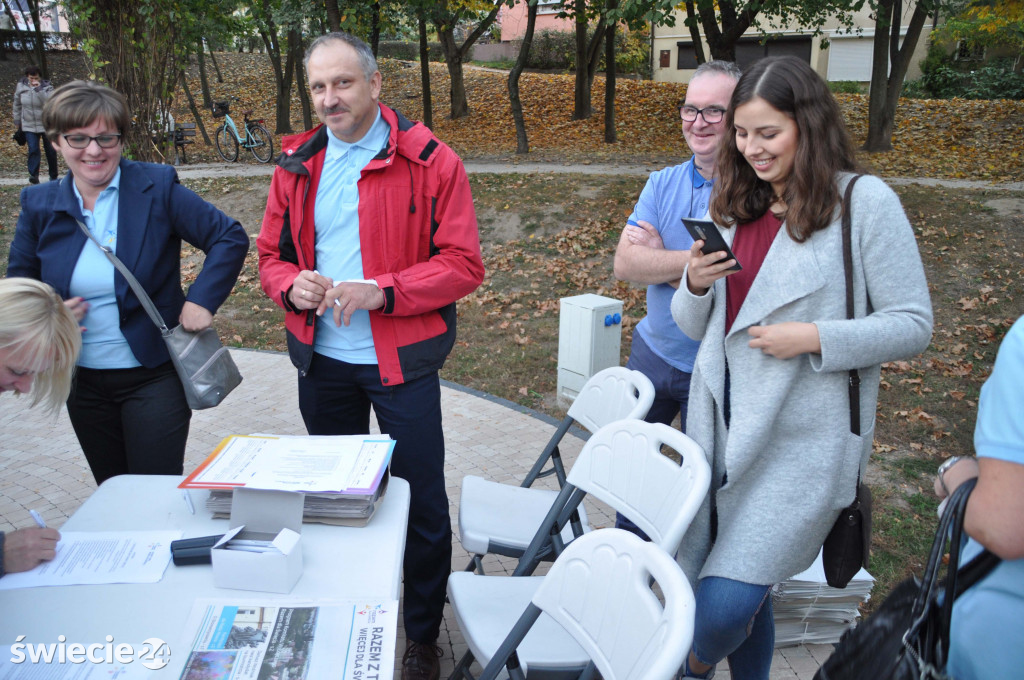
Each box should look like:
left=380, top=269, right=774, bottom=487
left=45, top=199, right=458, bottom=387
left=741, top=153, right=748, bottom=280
left=68, top=362, right=191, bottom=484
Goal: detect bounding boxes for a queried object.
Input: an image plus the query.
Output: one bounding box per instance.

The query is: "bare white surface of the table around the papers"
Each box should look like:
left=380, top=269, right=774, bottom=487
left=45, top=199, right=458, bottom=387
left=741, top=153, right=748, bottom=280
left=0, top=475, right=409, bottom=678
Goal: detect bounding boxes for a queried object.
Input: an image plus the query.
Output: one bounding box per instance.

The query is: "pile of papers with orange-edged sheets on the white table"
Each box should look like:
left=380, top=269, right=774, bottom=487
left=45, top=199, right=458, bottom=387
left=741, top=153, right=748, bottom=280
left=180, top=434, right=394, bottom=525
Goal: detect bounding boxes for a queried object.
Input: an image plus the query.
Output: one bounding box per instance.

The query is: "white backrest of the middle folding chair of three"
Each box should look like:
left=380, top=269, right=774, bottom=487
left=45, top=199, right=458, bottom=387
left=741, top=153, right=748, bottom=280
left=568, top=420, right=711, bottom=555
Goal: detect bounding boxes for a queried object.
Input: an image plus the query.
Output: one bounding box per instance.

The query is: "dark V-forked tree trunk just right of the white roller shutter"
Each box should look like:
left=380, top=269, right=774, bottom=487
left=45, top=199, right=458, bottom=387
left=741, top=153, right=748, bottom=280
left=864, top=0, right=935, bottom=152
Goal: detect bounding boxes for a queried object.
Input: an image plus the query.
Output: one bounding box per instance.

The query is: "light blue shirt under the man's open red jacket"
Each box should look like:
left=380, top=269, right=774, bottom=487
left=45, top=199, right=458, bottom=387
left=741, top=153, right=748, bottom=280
left=313, top=109, right=391, bottom=364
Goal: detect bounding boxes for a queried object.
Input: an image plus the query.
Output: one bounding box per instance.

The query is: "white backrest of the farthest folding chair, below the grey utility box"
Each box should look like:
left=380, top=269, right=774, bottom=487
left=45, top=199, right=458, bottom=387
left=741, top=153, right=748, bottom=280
left=568, top=366, right=654, bottom=432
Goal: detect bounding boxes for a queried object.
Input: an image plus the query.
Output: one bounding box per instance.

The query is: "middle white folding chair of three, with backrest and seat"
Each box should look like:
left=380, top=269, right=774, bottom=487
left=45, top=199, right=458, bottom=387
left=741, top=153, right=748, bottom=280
left=447, top=420, right=711, bottom=679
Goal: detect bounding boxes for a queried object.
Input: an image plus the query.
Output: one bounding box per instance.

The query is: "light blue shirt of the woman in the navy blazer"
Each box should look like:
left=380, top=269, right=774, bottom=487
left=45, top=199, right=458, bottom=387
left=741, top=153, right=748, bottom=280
left=71, top=168, right=141, bottom=369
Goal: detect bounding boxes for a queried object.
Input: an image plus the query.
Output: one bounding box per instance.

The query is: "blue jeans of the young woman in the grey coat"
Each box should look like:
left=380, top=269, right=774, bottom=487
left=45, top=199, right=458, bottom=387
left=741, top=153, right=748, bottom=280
left=693, top=577, right=775, bottom=680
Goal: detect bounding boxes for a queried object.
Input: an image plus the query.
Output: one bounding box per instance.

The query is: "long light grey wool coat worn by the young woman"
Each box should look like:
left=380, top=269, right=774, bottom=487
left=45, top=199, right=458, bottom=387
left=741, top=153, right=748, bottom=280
left=672, top=173, right=932, bottom=585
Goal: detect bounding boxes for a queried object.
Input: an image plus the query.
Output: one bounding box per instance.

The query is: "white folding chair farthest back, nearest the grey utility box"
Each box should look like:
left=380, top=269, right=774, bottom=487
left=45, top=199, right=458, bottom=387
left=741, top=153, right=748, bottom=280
left=459, top=366, right=654, bottom=573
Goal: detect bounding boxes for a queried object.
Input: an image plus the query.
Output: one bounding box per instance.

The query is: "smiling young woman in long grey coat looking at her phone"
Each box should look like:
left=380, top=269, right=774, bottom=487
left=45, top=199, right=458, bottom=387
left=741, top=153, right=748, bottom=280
left=672, top=57, right=932, bottom=680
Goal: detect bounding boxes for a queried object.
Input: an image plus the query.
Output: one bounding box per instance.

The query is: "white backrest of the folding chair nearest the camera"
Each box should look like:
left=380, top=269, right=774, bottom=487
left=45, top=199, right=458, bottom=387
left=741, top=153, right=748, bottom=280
left=532, top=528, right=695, bottom=680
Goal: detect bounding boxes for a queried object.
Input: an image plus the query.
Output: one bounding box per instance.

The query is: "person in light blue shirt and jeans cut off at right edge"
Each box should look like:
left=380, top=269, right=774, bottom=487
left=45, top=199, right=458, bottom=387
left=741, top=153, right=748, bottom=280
left=935, top=316, right=1024, bottom=680
